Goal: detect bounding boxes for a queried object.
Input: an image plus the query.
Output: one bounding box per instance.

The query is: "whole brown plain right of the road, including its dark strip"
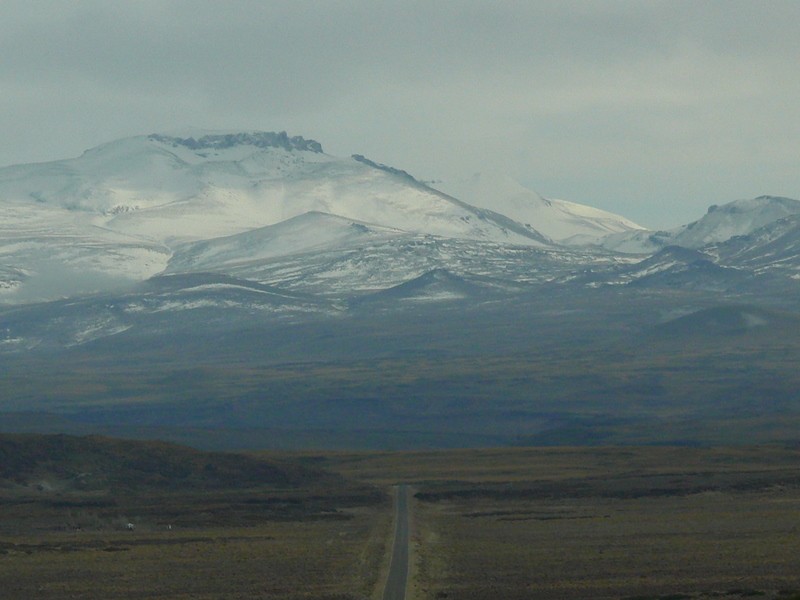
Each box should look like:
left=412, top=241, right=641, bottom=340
left=322, top=447, right=800, bottom=600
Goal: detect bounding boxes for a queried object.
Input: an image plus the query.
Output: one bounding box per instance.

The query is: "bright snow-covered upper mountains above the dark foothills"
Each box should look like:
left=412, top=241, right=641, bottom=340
left=0, top=131, right=800, bottom=314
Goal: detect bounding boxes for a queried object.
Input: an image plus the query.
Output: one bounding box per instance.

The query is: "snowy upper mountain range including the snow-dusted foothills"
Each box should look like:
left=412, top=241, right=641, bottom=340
left=0, top=131, right=800, bottom=347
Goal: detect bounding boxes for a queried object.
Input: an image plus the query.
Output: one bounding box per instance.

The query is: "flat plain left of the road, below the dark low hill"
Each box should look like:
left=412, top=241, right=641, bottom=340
left=0, top=464, right=392, bottom=600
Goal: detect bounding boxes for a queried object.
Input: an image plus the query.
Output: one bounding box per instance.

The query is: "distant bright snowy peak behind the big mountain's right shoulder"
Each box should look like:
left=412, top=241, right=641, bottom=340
left=436, top=173, right=644, bottom=245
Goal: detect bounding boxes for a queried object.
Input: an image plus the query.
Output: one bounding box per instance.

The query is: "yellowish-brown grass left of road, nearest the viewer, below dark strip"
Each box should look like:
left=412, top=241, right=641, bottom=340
left=0, top=512, right=384, bottom=600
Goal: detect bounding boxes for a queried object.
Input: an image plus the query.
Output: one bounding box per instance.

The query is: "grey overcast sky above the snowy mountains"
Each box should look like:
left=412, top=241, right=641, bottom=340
left=0, top=0, right=800, bottom=227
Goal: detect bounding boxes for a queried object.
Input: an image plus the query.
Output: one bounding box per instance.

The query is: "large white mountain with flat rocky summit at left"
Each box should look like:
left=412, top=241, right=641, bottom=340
left=0, top=132, right=549, bottom=302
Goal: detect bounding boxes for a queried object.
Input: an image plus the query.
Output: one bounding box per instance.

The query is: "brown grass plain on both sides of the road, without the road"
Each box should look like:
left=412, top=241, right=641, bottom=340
left=0, top=440, right=800, bottom=600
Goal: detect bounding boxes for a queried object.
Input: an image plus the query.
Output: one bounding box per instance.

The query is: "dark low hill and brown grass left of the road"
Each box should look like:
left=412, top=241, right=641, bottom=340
left=0, top=436, right=392, bottom=600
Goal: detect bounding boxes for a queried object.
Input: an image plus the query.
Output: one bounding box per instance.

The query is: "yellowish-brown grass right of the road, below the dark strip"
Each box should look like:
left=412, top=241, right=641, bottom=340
left=418, top=492, right=800, bottom=600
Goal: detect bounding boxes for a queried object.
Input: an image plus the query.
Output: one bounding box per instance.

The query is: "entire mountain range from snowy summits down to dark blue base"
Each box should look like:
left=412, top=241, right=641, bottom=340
left=7, top=131, right=800, bottom=448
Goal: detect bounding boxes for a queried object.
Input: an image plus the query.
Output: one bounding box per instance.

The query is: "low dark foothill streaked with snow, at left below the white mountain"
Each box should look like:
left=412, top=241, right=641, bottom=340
left=0, top=273, right=338, bottom=354
